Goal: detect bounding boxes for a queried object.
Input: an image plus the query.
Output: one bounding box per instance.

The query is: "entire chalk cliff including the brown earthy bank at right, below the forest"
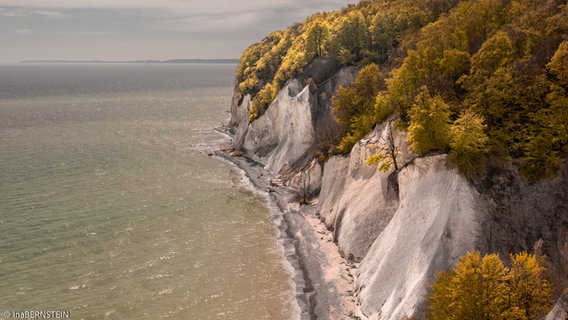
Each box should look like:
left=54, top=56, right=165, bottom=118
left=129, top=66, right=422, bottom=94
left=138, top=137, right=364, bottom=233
left=229, top=63, right=568, bottom=320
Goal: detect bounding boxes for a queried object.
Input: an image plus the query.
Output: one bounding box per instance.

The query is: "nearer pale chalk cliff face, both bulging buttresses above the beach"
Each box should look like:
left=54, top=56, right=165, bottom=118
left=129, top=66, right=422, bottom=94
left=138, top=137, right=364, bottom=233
left=319, top=125, right=484, bottom=319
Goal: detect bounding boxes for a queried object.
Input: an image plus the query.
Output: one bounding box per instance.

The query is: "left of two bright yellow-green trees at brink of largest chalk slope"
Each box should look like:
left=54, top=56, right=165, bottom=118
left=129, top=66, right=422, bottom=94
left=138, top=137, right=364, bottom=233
left=407, top=87, right=450, bottom=155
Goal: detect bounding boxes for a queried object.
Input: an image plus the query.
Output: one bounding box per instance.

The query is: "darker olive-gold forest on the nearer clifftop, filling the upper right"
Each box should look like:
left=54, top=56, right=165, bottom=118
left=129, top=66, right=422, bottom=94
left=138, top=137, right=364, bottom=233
left=386, top=0, right=568, bottom=181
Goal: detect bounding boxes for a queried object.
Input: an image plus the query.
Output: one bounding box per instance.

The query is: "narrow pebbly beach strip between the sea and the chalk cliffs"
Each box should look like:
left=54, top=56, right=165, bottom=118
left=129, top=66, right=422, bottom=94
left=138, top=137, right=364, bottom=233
left=209, top=128, right=366, bottom=320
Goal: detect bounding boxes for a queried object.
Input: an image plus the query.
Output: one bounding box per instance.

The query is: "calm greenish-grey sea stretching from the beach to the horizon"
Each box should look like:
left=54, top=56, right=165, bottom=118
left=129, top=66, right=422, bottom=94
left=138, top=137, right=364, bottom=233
left=0, top=64, right=296, bottom=319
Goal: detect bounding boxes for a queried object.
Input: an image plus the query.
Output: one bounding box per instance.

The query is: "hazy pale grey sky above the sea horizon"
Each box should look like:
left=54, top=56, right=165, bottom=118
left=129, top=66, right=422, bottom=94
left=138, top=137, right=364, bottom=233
left=0, top=0, right=356, bottom=62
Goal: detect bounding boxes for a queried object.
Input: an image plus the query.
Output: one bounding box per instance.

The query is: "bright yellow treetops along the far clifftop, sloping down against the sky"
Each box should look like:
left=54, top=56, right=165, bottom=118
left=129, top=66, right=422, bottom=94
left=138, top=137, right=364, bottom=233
left=237, top=0, right=457, bottom=119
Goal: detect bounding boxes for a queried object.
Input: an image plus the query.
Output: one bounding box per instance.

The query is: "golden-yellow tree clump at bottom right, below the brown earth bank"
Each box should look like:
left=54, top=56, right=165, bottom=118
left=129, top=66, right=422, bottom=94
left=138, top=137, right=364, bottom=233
left=429, top=252, right=551, bottom=320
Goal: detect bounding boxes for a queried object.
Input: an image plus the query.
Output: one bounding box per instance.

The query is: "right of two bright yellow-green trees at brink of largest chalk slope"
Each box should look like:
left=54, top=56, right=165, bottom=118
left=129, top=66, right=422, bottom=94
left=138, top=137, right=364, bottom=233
left=450, top=109, right=489, bottom=175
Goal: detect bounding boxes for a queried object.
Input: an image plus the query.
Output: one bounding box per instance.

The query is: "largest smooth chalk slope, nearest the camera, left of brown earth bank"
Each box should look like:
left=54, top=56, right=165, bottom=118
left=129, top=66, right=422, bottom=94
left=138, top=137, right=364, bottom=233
left=357, top=155, right=480, bottom=320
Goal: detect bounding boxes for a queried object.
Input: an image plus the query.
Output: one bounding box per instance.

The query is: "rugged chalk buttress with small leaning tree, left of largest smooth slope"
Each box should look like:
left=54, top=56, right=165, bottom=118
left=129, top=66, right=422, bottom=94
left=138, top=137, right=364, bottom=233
left=319, top=123, right=411, bottom=261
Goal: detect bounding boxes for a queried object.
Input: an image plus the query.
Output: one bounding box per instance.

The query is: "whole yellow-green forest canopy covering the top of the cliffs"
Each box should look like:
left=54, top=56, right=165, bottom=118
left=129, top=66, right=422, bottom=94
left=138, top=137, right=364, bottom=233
left=237, top=0, right=568, bottom=180
